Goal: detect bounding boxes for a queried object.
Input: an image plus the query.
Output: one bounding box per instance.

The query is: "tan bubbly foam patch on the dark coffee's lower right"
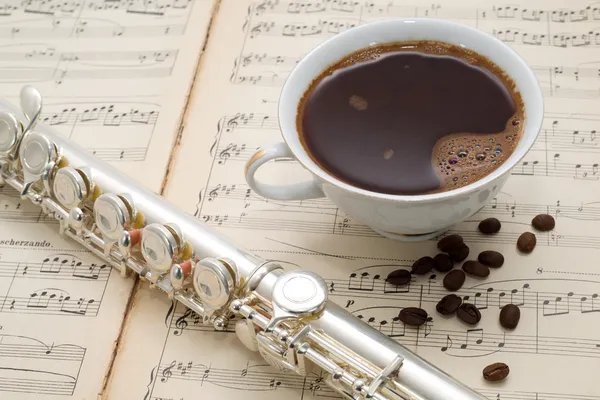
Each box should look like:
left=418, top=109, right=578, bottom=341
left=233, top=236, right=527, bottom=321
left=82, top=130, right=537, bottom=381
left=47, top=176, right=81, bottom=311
left=433, top=115, right=522, bottom=192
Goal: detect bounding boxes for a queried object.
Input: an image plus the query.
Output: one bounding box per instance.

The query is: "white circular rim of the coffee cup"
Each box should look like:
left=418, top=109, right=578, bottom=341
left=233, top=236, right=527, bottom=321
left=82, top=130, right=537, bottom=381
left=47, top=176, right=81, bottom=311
left=278, top=17, right=544, bottom=203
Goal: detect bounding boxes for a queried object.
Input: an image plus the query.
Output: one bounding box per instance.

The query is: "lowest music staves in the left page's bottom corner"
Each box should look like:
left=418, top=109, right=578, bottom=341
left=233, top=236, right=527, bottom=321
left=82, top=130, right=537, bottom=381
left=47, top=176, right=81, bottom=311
left=0, top=334, right=86, bottom=396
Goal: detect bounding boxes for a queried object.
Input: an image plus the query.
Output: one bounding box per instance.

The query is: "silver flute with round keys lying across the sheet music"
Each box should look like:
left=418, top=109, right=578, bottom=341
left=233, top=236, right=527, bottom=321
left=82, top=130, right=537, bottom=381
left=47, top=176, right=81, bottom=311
left=0, top=86, right=485, bottom=400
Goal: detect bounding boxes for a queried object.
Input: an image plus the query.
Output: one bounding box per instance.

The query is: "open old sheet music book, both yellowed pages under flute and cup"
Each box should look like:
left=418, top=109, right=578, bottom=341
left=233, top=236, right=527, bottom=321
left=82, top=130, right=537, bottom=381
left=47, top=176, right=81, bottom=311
left=0, top=0, right=600, bottom=400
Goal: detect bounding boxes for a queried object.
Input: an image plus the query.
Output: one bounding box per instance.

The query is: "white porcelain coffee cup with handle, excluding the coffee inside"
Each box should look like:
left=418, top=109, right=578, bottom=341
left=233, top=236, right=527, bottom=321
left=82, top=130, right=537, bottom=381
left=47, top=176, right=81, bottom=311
left=245, top=18, right=544, bottom=241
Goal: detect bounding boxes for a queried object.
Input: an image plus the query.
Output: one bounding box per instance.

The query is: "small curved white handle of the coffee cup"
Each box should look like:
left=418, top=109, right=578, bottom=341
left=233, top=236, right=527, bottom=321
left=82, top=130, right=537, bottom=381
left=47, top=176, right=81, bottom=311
left=244, top=142, right=325, bottom=200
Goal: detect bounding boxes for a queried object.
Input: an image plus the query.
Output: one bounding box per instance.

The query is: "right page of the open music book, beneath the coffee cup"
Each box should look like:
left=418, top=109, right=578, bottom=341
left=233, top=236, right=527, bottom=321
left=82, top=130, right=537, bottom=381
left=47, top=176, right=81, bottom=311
left=109, top=0, right=600, bottom=400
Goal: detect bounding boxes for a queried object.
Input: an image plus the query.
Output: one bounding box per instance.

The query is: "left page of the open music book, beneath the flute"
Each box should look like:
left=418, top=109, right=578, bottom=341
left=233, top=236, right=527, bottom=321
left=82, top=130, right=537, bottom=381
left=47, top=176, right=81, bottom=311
left=0, top=0, right=215, bottom=400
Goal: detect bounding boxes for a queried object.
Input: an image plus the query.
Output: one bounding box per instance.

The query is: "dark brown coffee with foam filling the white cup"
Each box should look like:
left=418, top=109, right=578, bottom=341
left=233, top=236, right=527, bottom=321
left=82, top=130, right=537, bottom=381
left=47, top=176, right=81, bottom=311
left=297, top=41, right=524, bottom=195
